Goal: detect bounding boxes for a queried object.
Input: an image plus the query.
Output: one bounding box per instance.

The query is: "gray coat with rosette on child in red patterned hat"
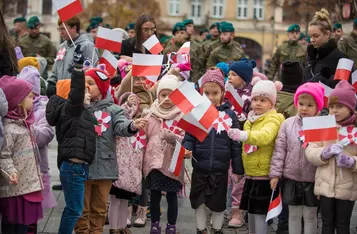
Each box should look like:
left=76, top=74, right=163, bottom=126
left=88, top=95, right=136, bottom=180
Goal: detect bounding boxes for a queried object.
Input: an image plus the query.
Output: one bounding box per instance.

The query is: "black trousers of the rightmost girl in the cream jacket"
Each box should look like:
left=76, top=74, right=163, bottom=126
left=320, top=196, right=355, bottom=234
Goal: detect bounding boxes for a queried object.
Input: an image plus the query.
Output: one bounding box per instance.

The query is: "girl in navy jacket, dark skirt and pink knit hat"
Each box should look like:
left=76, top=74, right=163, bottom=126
left=183, top=69, right=244, bottom=234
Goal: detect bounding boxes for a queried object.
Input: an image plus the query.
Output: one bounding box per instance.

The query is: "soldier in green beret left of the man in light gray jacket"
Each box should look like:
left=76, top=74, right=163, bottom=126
left=19, top=16, right=57, bottom=79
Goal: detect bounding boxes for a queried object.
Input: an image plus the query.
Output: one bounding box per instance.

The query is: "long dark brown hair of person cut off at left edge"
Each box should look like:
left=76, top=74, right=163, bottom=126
left=0, top=9, right=19, bottom=75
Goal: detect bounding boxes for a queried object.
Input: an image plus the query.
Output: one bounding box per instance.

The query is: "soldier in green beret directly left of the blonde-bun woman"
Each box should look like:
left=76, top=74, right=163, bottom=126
left=267, top=24, right=307, bottom=80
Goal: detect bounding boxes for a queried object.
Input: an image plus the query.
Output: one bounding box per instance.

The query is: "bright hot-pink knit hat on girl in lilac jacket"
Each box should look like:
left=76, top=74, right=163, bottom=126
left=294, top=82, right=325, bottom=111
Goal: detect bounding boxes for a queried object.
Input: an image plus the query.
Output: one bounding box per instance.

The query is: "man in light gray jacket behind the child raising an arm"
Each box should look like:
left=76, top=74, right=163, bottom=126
left=47, top=16, right=98, bottom=97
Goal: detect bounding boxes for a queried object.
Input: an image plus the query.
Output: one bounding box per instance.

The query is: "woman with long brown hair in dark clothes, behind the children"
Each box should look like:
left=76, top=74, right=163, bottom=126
left=121, top=14, right=156, bottom=57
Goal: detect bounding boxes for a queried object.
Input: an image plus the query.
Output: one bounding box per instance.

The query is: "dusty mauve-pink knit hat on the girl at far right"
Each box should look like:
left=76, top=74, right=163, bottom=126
left=328, top=80, right=357, bottom=112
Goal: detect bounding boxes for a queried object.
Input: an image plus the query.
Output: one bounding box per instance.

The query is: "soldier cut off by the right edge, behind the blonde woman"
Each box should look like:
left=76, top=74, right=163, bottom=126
left=338, top=18, right=357, bottom=68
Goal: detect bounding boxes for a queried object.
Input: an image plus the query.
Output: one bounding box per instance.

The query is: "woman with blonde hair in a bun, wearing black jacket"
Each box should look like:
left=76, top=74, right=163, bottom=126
left=304, top=8, right=346, bottom=88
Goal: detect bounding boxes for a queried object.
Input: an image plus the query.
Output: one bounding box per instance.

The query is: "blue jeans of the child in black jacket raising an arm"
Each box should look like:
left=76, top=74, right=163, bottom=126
left=58, top=161, right=89, bottom=234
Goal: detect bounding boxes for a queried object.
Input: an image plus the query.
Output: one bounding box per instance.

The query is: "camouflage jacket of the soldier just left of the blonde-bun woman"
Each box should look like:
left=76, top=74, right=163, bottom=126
left=267, top=41, right=307, bottom=80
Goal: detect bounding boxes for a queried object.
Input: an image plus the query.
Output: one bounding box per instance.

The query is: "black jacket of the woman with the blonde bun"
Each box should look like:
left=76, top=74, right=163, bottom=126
left=304, top=39, right=347, bottom=88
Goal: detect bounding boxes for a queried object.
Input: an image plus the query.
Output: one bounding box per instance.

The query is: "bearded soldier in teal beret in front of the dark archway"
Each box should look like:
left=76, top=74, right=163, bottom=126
left=206, top=22, right=245, bottom=68
